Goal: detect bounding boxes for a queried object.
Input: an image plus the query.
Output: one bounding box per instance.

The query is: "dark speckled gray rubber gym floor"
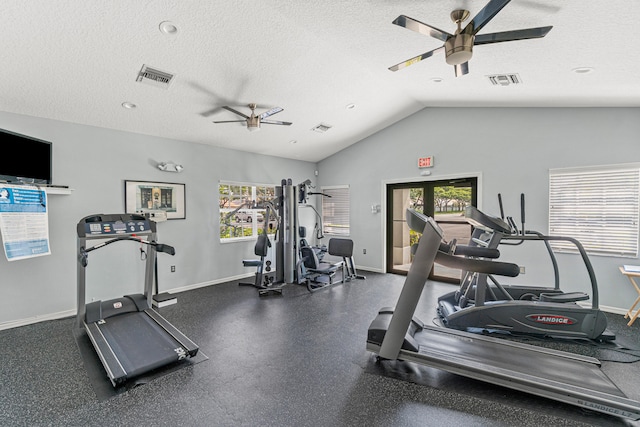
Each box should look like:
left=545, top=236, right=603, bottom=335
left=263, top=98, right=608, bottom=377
left=0, top=272, right=640, bottom=426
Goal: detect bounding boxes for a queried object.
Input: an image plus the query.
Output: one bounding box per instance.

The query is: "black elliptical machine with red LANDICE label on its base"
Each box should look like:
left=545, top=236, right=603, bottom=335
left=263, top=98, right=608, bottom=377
left=438, top=194, right=615, bottom=341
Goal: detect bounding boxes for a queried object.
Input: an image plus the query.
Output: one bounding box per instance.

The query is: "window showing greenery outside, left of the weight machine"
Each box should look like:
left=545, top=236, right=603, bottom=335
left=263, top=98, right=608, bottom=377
left=218, top=182, right=278, bottom=241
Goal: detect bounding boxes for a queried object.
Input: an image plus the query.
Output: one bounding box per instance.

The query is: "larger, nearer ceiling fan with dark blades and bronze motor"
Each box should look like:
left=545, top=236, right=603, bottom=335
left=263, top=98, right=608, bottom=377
left=389, top=0, right=553, bottom=77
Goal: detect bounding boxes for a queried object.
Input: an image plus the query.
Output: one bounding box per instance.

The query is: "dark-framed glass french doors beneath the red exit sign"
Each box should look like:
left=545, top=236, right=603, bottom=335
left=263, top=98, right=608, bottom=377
left=387, top=177, right=477, bottom=283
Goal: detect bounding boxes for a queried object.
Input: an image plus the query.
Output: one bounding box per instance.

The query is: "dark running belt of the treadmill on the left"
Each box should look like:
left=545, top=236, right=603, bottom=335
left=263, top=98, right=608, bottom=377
left=98, top=312, right=181, bottom=378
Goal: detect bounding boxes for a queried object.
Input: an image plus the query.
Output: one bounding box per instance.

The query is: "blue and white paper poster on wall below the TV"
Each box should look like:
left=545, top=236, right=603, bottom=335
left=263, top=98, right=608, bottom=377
left=0, top=183, right=51, bottom=261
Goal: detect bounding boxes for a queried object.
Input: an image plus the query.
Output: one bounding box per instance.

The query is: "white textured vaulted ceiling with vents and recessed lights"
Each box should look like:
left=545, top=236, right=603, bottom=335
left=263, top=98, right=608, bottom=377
left=0, top=0, right=640, bottom=162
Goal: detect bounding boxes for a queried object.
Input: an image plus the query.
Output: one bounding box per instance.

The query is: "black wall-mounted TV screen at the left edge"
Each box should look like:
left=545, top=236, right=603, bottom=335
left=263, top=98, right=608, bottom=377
left=0, top=129, right=52, bottom=184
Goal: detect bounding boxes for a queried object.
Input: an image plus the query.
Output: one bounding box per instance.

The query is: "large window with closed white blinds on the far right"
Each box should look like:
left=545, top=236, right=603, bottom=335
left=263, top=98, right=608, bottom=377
left=549, top=165, right=640, bottom=258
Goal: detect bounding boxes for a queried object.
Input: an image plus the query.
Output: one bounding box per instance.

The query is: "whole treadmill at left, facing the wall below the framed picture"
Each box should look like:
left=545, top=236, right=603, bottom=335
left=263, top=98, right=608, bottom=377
left=76, top=214, right=198, bottom=387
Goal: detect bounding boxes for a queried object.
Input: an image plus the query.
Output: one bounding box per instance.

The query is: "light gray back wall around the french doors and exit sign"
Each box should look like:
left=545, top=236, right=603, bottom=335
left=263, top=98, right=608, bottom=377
left=318, top=108, right=640, bottom=311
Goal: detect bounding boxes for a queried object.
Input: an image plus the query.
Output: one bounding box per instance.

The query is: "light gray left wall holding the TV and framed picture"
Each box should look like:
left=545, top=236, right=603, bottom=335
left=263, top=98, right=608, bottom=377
left=0, top=112, right=316, bottom=329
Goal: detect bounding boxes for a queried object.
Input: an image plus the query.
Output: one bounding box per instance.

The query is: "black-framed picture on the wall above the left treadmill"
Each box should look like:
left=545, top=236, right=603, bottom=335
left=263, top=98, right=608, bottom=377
left=124, top=181, right=186, bottom=219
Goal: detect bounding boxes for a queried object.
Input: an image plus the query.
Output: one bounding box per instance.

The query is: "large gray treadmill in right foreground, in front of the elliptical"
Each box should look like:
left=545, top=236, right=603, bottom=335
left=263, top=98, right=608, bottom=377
left=367, top=209, right=640, bottom=420
